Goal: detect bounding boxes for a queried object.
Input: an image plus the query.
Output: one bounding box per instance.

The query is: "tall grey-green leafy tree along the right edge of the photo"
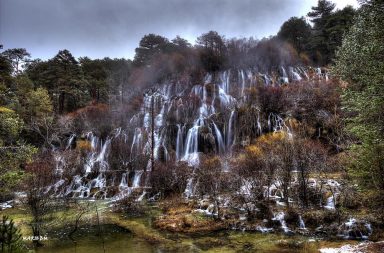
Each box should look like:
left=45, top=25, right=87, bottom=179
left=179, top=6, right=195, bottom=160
left=334, top=0, right=384, bottom=208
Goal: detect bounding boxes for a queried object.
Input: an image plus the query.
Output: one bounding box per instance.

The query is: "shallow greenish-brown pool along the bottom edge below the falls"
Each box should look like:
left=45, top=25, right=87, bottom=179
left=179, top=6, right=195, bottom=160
left=37, top=225, right=347, bottom=253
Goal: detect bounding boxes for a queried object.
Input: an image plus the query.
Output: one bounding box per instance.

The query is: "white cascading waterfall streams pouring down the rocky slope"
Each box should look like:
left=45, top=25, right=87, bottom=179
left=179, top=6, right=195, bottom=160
left=52, top=67, right=325, bottom=198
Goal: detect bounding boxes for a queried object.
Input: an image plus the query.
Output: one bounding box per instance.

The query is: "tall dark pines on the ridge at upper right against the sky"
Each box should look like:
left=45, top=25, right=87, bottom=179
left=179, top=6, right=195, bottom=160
left=277, top=0, right=356, bottom=65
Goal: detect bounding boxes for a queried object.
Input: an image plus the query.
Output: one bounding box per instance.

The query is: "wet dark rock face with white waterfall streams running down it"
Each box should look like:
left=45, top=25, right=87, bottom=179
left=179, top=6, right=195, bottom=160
left=51, top=66, right=330, bottom=198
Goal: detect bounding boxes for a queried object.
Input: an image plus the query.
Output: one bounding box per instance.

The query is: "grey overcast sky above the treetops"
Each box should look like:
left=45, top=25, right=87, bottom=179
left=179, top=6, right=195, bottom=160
left=0, top=0, right=358, bottom=59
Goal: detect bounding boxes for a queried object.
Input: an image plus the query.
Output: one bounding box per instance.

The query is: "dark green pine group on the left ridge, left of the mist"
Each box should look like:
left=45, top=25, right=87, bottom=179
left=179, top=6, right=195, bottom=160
left=25, top=53, right=131, bottom=114
